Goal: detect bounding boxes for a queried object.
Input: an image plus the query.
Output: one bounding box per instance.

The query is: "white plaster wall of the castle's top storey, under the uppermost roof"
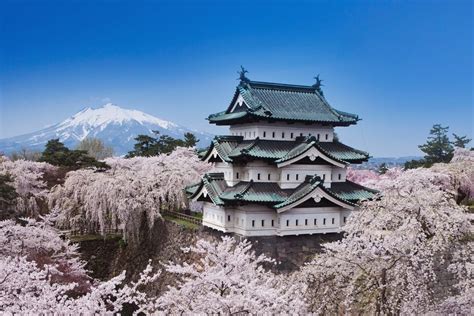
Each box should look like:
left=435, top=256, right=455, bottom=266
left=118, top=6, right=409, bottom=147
left=229, top=122, right=334, bottom=142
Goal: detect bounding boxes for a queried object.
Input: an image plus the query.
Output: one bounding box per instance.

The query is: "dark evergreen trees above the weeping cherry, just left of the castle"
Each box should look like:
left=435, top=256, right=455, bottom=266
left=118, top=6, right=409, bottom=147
left=126, top=131, right=199, bottom=158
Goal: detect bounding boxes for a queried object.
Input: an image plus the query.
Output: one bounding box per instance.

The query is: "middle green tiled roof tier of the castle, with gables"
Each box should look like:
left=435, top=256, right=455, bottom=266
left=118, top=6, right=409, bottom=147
left=202, top=136, right=369, bottom=164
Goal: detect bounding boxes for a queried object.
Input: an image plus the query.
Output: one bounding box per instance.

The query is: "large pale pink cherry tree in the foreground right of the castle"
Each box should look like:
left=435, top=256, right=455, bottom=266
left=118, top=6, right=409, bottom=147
left=301, top=157, right=472, bottom=314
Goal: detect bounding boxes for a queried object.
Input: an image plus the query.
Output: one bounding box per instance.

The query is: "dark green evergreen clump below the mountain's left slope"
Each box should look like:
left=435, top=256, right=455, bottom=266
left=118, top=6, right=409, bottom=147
left=39, top=139, right=109, bottom=169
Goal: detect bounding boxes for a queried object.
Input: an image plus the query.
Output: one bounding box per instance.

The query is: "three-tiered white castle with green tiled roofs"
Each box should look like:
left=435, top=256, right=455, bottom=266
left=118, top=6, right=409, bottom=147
left=186, top=68, right=376, bottom=236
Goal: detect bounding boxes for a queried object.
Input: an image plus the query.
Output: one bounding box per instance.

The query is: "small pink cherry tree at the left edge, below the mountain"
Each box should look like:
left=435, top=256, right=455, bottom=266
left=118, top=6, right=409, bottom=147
left=0, top=157, right=57, bottom=217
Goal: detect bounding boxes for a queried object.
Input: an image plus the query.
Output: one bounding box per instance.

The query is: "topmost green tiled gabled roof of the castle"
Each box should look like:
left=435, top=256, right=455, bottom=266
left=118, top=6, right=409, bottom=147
left=208, top=80, right=359, bottom=126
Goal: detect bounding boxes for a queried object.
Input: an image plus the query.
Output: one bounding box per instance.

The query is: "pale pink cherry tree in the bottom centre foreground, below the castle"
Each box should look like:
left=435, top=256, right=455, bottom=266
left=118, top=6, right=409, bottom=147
left=157, top=237, right=305, bottom=315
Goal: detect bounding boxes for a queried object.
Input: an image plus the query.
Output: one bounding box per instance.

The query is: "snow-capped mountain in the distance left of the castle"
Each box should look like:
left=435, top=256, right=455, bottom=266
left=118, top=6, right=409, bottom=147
left=0, top=103, right=213, bottom=155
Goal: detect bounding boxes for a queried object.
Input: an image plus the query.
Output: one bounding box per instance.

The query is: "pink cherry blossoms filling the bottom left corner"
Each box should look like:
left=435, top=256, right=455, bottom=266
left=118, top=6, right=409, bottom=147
left=0, top=217, right=159, bottom=315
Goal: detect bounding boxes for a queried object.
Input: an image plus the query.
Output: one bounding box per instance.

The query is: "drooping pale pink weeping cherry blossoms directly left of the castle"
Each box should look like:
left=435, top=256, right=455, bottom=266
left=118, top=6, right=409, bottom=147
left=49, top=147, right=210, bottom=241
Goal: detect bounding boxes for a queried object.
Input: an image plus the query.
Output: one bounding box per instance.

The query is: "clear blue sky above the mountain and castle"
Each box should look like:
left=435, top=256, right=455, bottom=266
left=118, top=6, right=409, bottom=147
left=0, top=0, right=474, bottom=156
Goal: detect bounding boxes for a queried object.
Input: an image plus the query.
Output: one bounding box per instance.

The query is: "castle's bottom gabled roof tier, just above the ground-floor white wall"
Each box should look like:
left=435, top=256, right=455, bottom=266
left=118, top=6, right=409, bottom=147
left=186, top=173, right=378, bottom=211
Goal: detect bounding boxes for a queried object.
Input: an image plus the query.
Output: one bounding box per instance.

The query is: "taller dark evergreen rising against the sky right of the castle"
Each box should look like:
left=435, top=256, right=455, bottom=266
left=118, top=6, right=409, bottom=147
left=418, top=124, right=454, bottom=167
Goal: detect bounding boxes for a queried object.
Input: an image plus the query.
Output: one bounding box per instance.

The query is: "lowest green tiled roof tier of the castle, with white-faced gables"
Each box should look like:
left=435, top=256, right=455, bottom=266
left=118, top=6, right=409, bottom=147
left=188, top=173, right=377, bottom=209
